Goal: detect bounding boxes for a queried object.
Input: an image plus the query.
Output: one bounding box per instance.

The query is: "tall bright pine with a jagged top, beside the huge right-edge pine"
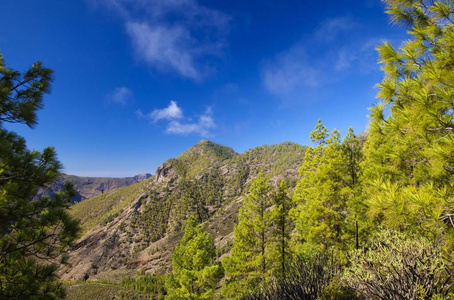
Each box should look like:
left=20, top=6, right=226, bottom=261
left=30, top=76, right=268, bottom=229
left=295, top=120, right=346, bottom=252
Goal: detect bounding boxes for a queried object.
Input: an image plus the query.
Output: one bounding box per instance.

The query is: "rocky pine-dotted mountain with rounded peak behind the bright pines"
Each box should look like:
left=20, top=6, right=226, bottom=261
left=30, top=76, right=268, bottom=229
left=59, top=140, right=306, bottom=281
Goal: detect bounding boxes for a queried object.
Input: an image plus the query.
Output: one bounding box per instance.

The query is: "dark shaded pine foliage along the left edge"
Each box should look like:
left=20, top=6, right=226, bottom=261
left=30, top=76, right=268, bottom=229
left=0, top=55, right=79, bottom=299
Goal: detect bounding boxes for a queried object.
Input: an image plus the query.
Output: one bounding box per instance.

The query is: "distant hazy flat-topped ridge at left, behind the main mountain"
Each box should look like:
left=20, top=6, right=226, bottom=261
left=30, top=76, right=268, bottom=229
left=36, top=173, right=151, bottom=203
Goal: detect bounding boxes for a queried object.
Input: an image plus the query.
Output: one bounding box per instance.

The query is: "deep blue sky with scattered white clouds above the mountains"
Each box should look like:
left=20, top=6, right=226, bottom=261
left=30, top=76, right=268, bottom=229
left=0, top=0, right=407, bottom=177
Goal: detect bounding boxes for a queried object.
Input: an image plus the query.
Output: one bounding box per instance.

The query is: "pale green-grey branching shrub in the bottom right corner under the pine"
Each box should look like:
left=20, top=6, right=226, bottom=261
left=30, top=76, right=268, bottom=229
left=343, top=230, right=454, bottom=300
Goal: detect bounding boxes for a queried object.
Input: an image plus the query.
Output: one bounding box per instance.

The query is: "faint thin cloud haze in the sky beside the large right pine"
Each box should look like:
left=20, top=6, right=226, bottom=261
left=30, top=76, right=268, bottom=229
left=261, top=17, right=379, bottom=101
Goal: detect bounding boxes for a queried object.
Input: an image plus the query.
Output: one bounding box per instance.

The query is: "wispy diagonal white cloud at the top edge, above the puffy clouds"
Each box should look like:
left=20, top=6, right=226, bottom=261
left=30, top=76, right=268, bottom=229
left=94, top=0, right=230, bottom=81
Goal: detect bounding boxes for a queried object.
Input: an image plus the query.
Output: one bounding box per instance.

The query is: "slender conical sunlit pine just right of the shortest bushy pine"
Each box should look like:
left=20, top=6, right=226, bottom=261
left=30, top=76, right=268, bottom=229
left=222, top=172, right=271, bottom=296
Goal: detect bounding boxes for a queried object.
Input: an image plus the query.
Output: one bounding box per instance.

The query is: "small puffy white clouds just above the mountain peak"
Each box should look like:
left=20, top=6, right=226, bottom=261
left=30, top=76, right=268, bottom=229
left=136, top=101, right=216, bottom=137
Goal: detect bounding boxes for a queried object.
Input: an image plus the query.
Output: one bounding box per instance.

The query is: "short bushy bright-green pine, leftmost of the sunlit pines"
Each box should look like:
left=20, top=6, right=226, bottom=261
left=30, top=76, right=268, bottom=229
left=166, top=216, right=223, bottom=299
